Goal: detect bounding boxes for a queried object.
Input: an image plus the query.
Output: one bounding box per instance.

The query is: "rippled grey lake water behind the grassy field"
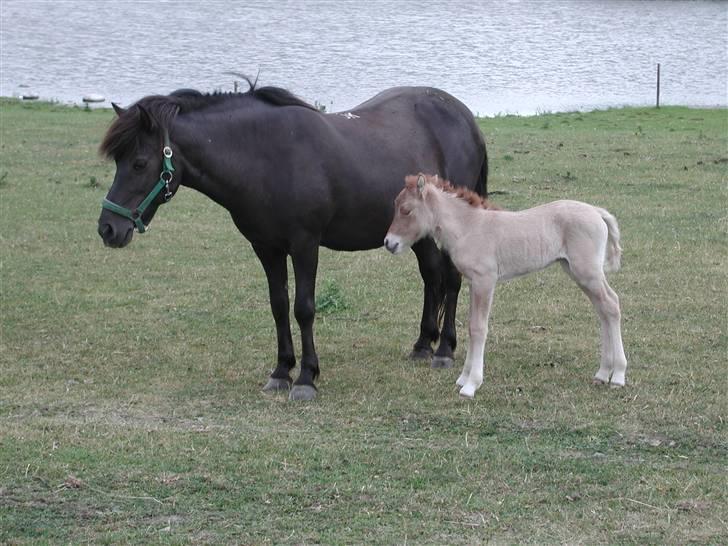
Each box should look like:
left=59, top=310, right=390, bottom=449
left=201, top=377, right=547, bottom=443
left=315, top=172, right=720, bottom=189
left=0, top=0, right=728, bottom=115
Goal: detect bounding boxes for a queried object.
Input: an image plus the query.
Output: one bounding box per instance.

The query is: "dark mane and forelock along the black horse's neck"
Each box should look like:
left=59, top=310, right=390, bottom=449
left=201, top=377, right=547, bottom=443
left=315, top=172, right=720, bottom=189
left=99, top=74, right=317, bottom=158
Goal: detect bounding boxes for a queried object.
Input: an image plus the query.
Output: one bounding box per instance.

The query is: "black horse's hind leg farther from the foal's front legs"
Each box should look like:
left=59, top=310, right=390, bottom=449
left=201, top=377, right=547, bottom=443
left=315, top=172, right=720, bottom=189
left=410, top=238, right=445, bottom=360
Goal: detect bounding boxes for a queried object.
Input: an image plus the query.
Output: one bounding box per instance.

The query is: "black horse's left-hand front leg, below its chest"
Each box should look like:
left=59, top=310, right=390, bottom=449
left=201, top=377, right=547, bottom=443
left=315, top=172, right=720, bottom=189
left=253, top=245, right=296, bottom=391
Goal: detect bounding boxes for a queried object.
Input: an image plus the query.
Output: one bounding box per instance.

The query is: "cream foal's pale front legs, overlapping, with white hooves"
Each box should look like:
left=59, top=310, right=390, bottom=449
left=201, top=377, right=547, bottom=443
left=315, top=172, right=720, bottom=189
left=457, top=279, right=495, bottom=398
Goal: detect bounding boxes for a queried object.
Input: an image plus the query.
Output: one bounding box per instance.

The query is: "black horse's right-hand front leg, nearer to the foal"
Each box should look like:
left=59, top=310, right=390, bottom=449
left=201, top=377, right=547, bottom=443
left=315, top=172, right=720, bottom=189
left=289, top=240, right=319, bottom=400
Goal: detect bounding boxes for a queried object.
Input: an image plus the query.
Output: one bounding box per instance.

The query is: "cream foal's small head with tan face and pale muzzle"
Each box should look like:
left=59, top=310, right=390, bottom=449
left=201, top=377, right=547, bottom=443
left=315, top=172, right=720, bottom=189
left=384, top=173, right=434, bottom=254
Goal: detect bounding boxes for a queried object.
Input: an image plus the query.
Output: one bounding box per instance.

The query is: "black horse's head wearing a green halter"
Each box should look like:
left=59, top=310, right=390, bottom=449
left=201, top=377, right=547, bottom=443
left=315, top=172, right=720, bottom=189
left=98, top=103, right=179, bottom=248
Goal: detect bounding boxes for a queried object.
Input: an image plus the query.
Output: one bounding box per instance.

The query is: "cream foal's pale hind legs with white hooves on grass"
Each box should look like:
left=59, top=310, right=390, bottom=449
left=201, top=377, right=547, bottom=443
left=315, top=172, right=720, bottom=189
left=564, top=264, right=627, bottom=386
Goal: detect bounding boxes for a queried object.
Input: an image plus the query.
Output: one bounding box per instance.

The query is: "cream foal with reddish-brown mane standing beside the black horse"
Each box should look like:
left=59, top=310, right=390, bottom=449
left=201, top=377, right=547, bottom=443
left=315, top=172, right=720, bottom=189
left=384, top=174, right=627, bottom=398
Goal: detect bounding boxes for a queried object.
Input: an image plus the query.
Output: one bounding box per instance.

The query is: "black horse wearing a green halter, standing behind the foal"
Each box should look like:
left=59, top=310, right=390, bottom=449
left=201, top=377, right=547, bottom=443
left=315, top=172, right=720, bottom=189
left=98, top=82, right=487, bottom=400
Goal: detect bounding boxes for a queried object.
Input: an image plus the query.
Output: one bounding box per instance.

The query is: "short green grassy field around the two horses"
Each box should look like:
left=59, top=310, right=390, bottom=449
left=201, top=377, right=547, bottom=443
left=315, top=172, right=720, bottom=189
left=0, top=100, right=728, bottom=544
